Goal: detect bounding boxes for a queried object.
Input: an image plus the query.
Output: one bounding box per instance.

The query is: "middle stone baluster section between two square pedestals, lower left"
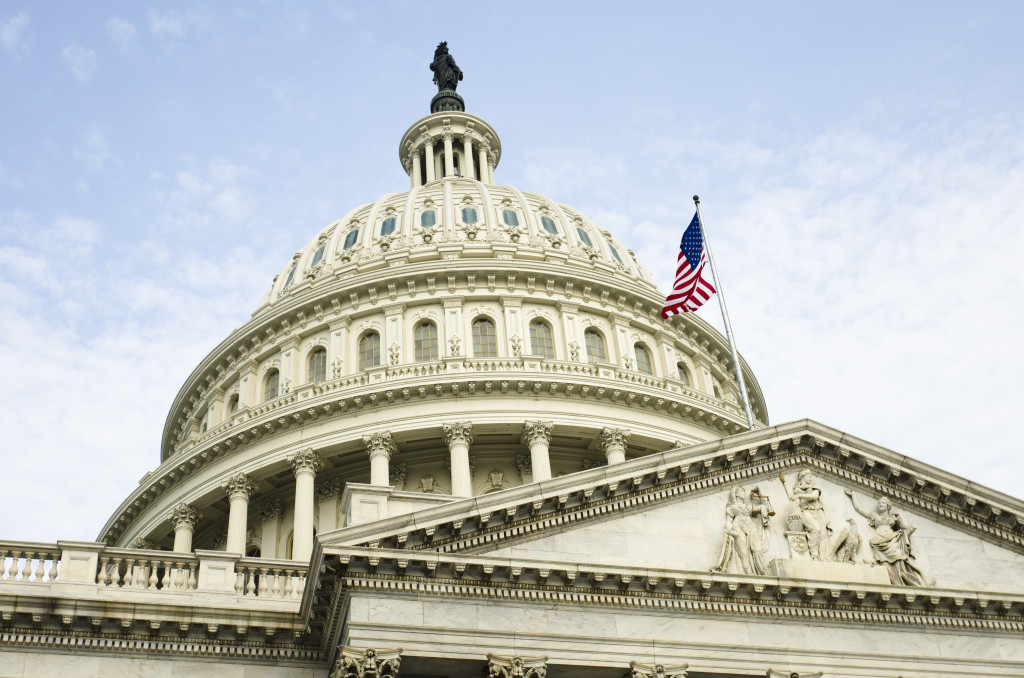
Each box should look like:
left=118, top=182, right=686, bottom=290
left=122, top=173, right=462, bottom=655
left=96, top=548, right=200, bottom=592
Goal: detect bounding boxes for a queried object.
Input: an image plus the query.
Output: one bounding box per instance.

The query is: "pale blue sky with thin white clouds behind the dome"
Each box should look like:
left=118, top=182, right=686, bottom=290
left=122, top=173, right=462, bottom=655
left=0, top=0, right=1024, bottom=542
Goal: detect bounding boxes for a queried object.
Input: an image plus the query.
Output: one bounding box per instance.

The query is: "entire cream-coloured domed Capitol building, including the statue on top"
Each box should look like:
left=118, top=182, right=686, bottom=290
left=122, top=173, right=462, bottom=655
left=0, top=43, right=1024, bottom=678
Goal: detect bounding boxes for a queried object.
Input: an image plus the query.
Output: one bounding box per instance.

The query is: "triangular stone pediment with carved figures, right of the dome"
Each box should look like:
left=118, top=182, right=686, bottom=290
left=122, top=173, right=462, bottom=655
left=322, top=421, right=1024, bottom=592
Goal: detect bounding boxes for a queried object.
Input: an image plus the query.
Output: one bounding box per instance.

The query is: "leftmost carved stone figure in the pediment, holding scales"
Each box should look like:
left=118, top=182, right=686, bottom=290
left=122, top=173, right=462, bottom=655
left=712, top=485, right=772, bottom=575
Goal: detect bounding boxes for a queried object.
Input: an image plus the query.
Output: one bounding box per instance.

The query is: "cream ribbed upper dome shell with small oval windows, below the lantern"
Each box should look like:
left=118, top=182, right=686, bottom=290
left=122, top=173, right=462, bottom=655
left=256, top=178, right=653, bottom=314
